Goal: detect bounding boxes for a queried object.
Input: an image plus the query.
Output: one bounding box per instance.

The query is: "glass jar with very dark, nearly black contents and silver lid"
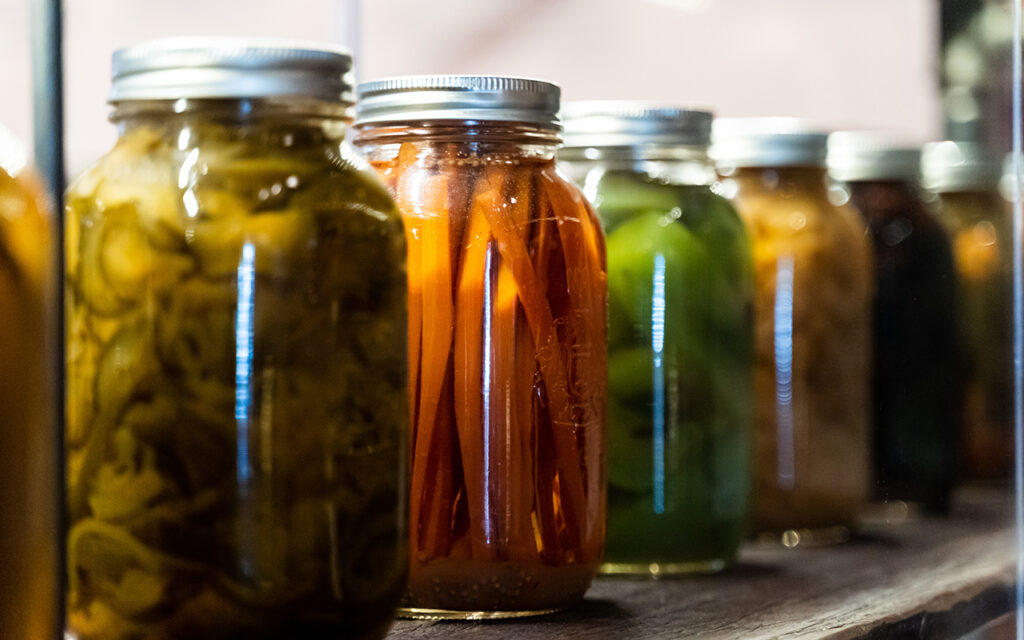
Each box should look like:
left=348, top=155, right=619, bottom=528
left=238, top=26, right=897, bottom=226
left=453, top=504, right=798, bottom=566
left=828, top=132, right=963, bottom=513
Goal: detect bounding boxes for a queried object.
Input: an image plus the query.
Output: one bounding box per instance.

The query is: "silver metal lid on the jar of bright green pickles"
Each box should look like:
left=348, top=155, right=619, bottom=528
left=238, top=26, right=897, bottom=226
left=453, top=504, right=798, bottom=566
left=561, top=100, right=713, bottom=148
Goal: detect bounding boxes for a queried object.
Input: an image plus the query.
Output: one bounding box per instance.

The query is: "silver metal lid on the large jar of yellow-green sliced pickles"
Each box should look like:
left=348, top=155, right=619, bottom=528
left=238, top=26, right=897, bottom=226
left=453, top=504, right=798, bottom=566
left=110, top=37, right=352, bottom=104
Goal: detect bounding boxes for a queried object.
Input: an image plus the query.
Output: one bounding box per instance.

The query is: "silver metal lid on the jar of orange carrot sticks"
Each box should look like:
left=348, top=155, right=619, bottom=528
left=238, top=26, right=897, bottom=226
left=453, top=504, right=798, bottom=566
left=355, top=76, right=561, bottom=131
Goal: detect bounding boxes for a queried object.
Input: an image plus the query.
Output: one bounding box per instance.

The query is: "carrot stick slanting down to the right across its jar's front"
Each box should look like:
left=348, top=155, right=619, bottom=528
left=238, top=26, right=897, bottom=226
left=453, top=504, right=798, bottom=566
left=471, top=164, right=586, bottom=545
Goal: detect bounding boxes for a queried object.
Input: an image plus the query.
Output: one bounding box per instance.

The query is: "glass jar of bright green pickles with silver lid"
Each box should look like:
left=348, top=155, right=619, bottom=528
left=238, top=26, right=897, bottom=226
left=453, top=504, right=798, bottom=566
left=559, top=102, right=754, bottom=575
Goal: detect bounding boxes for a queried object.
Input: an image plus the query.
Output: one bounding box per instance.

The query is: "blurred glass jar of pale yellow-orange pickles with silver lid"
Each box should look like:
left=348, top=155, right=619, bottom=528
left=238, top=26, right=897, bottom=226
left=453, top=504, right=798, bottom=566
left=713, top=119, right=872, bottom=546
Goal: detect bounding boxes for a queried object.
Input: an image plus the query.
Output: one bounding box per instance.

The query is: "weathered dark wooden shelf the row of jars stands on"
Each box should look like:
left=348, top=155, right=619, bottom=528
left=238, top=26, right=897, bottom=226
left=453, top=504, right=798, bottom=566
left=388, top=488, right=1016, bottom=640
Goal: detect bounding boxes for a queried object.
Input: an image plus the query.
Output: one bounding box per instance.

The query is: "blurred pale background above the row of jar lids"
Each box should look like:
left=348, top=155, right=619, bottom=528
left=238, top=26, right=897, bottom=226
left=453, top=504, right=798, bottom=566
left=0, top=0, right=1012, bottom=177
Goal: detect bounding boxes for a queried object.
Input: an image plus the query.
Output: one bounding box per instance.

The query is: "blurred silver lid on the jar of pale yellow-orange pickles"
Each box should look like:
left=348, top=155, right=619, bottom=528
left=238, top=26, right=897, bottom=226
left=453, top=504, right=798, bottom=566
left=711, top=118, right=828, bottom=168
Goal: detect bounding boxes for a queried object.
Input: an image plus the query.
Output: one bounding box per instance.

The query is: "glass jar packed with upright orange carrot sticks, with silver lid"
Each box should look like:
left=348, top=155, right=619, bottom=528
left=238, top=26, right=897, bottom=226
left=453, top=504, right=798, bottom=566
left=355, top=76, right=607, bottom=617
